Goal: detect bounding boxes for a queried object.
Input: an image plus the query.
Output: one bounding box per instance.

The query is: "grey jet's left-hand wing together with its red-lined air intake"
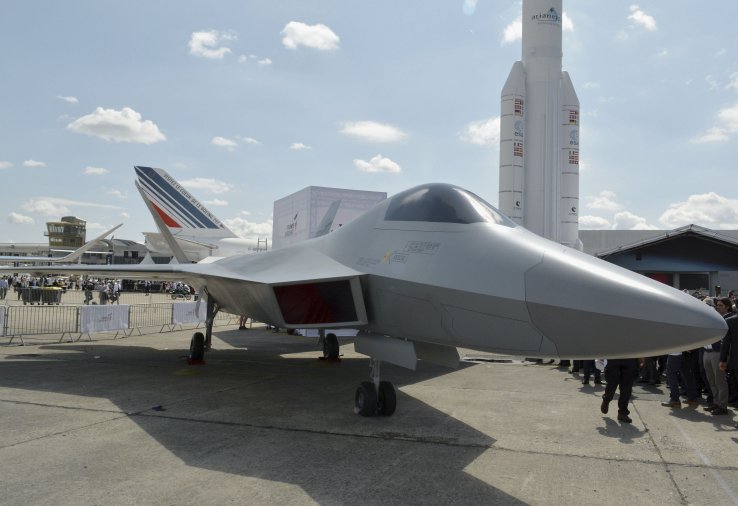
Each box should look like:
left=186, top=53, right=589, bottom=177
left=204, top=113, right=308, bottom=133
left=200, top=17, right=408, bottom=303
left=7, top=248, right=368, bottom=328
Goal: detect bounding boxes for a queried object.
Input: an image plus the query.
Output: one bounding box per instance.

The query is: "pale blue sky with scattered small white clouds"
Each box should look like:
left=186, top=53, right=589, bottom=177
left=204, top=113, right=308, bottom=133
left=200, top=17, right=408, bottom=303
left=0, top=0, right=738, bottom=243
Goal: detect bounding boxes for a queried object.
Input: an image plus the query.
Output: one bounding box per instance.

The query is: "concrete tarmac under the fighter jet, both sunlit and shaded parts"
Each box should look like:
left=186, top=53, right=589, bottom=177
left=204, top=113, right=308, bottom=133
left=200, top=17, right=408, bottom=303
left=0, top=327, right=738, bottom=506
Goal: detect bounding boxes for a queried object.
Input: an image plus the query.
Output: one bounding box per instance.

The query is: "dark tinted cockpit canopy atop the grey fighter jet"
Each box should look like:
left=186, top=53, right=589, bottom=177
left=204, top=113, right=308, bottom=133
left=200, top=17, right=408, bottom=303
left=384, top=183, right=515, bottom=227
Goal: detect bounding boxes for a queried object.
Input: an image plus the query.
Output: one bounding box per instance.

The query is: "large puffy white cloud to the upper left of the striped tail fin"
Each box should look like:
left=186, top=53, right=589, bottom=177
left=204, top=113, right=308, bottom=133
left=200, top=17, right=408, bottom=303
left=67, top=107, right=166, bottom=144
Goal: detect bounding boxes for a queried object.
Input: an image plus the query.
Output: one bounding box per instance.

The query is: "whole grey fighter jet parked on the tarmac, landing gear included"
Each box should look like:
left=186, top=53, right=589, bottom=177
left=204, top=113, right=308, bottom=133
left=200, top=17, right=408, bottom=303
left=10, top=184, right=727, bottom=416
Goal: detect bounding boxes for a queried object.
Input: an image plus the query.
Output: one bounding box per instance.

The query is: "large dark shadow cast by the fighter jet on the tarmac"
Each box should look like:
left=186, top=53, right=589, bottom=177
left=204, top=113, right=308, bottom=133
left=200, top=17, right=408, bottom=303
left=0, top=330, right=528, bottom=504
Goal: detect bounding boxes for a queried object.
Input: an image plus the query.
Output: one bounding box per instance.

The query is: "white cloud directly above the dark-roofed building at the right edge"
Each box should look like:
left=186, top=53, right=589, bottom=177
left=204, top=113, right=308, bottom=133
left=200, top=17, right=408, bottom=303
left=659, top=192, right=738, bottom=229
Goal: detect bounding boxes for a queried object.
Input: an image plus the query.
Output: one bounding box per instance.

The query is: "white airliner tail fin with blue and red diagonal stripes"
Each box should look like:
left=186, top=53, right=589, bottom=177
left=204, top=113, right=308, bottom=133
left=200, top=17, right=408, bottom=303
left=134, top=166, right=237, bottom=239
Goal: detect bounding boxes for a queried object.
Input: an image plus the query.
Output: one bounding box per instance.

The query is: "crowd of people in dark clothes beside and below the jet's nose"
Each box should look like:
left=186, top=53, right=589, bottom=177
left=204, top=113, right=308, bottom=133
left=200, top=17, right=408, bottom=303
left=560, top=291, right=738, bottom=428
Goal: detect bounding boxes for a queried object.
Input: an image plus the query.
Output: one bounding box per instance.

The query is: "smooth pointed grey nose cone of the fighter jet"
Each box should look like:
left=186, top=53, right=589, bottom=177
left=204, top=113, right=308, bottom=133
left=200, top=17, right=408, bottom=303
left=525, top=250, right=727, bottom=358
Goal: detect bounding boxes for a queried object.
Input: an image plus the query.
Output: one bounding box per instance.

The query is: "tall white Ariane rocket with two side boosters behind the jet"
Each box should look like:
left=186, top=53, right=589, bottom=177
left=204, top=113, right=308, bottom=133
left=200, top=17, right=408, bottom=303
left=499, top=0, right=581, bottom=250
